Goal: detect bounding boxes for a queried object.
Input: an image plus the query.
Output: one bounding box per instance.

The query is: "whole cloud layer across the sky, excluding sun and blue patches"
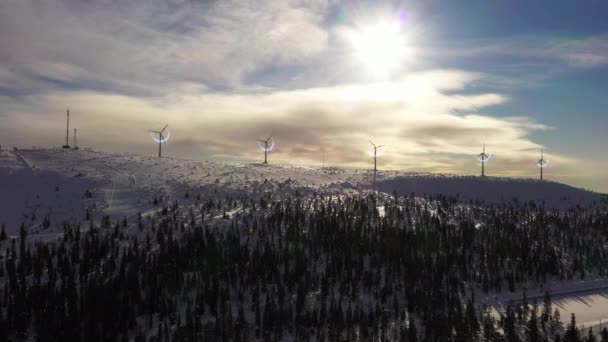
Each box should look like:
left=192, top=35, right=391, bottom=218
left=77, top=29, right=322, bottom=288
left=0, top=0, right=608, bottom=192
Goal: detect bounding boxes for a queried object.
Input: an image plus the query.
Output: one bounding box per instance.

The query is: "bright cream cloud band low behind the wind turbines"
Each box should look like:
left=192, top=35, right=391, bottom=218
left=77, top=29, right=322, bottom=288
left=0, top=70, right=573, bottom=176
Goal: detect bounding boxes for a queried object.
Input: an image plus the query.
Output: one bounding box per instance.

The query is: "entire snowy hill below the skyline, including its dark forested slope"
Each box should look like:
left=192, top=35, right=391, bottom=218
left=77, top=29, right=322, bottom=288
left=0, top=149, right=608, bottom=341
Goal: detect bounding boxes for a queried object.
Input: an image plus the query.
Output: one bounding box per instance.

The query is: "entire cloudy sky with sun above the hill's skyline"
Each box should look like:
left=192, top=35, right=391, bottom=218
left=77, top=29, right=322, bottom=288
left=0, top=0, right=608, bottom=193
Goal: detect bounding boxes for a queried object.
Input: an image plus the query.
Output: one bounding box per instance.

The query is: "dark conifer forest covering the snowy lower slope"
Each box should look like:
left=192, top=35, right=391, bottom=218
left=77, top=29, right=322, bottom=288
left=0, top=193, right=608, bottom=342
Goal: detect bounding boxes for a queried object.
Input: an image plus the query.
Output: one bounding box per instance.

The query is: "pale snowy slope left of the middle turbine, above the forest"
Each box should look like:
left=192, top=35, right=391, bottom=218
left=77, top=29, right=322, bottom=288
left=0, top=149, right=360, bottom=234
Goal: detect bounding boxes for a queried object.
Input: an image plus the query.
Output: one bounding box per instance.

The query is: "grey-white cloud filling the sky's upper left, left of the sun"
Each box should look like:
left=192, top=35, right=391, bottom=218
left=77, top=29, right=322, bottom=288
left=0, top=0, right=328, bottom=96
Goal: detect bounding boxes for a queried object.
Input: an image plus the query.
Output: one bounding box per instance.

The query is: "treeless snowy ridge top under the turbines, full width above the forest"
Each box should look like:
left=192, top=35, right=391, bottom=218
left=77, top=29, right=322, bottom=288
left=0, top=149, right=600, bottom=234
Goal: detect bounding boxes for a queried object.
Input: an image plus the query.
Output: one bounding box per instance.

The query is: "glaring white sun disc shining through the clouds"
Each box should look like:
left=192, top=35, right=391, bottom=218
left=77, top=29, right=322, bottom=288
left=350, top=21, right=405, bottom=75
